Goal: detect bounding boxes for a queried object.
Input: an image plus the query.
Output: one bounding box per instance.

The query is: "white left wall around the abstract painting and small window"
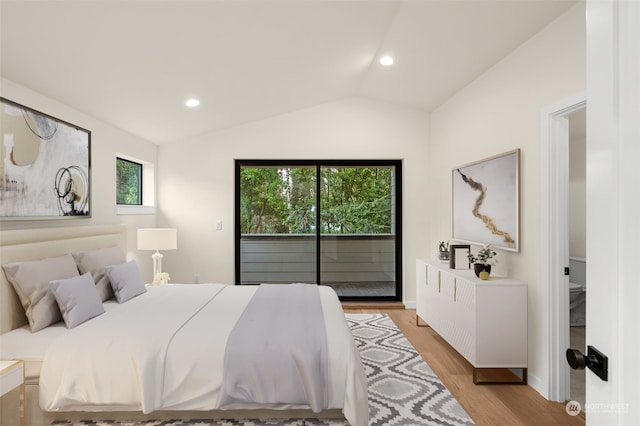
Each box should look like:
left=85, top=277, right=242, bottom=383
left=0, top=79, right=157, bottom=280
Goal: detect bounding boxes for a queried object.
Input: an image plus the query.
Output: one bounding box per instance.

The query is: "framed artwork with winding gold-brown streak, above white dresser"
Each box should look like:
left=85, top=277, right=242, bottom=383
left=452, top=149, right=520, bottom=252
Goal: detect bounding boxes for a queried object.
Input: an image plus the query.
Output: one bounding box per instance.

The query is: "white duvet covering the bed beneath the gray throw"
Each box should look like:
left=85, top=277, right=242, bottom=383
left=40, top=284, right=368, bottom=425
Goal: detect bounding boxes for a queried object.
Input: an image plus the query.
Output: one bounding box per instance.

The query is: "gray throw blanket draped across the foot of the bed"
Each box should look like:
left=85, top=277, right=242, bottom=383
left=219, top=284, right=329, bottom=412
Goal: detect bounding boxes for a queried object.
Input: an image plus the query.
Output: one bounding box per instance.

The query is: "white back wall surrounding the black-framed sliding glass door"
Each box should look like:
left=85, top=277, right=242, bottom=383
left=158, top=98, right=433, bottom=301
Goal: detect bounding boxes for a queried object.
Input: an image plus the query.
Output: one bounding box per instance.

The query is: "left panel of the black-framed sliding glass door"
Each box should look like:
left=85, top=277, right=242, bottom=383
left=236, top=163, right=318, bottom=284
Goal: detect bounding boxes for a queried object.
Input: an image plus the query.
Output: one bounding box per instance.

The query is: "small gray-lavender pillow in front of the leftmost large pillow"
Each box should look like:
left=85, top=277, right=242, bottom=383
left=50, top=272, right=104, bottom=328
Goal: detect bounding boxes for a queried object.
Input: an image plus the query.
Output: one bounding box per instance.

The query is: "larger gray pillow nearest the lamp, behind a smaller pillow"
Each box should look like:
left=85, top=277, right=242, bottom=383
left=72, top=246, right=127, bottom=302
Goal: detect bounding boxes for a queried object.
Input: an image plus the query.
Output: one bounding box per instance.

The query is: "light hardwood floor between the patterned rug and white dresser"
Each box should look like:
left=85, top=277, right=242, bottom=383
left=343, top=303, right=585, bottom=426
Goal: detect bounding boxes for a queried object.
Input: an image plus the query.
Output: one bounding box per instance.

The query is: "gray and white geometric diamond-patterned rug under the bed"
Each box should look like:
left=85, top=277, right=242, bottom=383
left=52, top=314, right=474, bottom=426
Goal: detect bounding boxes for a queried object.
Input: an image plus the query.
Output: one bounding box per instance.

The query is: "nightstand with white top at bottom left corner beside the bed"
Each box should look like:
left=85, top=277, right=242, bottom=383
left=0, top=361, right=24, bottom=426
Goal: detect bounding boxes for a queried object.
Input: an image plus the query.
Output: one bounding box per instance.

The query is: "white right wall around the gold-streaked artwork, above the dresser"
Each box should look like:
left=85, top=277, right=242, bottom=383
left=427, top=3, right=586, bottom=392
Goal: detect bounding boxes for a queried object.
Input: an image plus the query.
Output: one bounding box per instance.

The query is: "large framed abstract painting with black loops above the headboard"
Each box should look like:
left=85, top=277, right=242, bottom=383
left=0, top=98, right=91, bottom=220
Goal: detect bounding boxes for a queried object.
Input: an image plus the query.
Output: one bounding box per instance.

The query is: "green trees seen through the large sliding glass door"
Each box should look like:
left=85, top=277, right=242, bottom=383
left=240, top=167, right=393, bottom=234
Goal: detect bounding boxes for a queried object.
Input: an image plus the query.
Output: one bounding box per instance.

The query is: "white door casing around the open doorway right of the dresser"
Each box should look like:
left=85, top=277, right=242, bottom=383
left=538, top=93, right=587, bottom=402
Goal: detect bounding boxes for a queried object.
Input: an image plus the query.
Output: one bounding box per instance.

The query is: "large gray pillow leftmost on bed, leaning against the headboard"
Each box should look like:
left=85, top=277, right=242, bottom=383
left=2, top=254, right=78, bottom=332
